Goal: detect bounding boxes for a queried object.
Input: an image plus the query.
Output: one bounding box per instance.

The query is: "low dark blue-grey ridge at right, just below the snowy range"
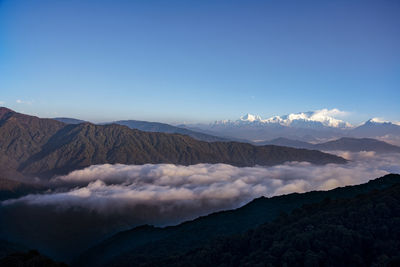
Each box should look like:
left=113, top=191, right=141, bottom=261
left=256, top=137, right=400, bottom=153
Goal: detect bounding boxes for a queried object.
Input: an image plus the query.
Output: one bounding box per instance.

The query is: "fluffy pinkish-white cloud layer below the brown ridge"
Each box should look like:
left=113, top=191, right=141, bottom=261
left=3, top=152, right=400, bottom=220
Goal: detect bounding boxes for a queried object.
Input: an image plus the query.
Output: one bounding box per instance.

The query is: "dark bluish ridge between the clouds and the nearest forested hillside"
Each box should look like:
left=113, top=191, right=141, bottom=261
left=75, top=175, right=400, bottom=266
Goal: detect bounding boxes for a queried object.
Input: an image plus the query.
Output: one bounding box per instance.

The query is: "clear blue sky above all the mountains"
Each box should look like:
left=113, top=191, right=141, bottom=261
left=0, top=0, right=400, bottom=122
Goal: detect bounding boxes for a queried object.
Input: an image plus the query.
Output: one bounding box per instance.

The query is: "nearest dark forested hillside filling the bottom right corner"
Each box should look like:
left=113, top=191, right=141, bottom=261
left=152, top=177, right=400, bottom=266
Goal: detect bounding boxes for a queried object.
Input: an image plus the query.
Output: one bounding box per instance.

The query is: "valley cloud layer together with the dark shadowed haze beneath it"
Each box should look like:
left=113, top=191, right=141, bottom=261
left=0, top=152, right=400, bottom=260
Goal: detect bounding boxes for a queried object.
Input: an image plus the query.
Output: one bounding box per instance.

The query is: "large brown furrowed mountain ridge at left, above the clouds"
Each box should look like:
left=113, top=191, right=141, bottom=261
left=0, top=108, right=346, bottom=181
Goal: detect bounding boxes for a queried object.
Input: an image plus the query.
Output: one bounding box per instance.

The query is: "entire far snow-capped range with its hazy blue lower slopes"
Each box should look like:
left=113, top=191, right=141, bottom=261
left=181, top=109, right=400, bottom=142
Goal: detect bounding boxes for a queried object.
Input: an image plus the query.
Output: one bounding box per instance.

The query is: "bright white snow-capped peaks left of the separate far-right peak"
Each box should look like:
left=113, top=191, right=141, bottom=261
left=214, top=109, right=352, bottom=129
